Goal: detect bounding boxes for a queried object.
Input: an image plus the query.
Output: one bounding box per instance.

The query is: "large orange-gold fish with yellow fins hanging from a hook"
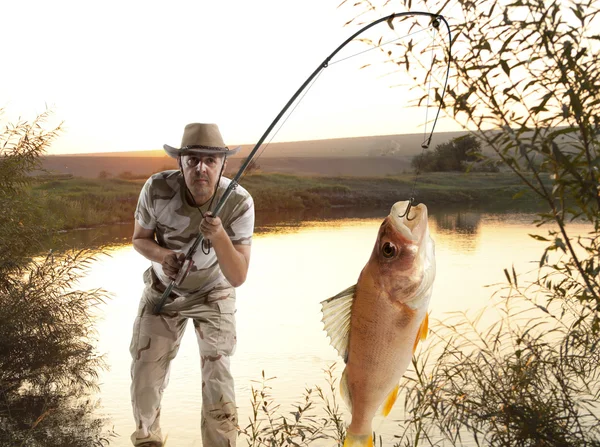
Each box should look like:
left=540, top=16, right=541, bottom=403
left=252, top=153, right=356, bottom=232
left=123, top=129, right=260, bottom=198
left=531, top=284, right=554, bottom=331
left=321, top=201, right=436, bottom=447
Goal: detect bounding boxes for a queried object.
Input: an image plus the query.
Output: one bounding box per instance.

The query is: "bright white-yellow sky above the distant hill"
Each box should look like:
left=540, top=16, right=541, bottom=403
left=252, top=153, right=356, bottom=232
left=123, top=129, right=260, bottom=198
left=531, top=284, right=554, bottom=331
left=0, top=0, right=459, bottom=154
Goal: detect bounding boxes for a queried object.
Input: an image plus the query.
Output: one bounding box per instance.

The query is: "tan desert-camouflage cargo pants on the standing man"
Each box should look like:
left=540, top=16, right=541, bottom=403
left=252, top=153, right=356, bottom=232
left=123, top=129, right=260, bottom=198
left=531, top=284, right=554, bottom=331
left=130, top=271, right=238, bottom=447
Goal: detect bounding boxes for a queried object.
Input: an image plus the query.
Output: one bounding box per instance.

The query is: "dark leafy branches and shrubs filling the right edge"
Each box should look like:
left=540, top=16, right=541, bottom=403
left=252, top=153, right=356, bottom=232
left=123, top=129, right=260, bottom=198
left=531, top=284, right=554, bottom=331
left=342, top=0, right=600, bottom=446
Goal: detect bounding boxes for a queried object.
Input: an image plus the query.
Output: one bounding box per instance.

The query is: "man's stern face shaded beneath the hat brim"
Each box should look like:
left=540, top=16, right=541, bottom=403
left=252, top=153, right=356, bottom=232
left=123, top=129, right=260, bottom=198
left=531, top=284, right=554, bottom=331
left=181, top=155, right=226, bottom=205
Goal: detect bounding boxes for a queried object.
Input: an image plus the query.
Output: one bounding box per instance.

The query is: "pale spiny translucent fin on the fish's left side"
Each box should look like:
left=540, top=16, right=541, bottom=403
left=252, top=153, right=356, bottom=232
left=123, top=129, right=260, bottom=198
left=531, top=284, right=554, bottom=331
left=321, top=285, right=356, bottom=363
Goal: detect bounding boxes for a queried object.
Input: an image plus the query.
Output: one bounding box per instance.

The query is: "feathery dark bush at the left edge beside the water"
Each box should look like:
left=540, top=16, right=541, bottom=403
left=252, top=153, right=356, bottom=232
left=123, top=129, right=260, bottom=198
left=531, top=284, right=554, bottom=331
left=0, top=113, right=108, bottom=447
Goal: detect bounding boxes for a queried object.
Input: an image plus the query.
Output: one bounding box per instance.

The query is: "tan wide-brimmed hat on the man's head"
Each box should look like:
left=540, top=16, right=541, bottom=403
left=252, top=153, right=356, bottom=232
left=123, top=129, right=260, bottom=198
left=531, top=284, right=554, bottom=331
left=163, top=123, right=240, bottom=158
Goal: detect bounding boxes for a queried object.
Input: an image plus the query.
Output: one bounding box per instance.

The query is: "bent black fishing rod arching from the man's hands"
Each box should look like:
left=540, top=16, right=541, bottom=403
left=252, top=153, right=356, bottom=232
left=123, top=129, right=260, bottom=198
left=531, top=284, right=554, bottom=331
left=154, top=11, right=452, bottom=315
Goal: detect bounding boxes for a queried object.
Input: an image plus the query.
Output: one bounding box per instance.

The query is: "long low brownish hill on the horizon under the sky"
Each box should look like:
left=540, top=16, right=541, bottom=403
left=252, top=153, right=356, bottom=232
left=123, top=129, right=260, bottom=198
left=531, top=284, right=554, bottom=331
left=42, top=132, right=474, bottom=178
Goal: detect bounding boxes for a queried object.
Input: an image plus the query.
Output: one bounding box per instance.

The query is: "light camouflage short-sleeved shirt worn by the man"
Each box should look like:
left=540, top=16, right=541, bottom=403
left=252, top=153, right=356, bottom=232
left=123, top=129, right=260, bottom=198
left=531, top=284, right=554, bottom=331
left=135, top=171, right=254, bottom=296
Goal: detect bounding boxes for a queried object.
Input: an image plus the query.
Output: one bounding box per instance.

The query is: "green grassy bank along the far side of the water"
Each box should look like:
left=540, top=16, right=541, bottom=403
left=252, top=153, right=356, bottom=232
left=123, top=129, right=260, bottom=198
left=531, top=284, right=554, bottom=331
left=31, top=172, right=539, bottom=230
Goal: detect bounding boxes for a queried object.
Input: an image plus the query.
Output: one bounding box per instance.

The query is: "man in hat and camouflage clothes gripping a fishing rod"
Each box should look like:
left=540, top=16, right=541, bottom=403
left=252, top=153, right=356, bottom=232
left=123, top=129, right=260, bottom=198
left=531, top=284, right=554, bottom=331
left=130, top=123, right=254, bottom=447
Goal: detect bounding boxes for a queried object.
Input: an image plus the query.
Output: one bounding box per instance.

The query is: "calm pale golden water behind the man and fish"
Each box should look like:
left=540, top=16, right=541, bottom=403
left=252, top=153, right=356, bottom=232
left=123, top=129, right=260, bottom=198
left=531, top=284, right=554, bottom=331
left=65, top=210, right=584, bottom=447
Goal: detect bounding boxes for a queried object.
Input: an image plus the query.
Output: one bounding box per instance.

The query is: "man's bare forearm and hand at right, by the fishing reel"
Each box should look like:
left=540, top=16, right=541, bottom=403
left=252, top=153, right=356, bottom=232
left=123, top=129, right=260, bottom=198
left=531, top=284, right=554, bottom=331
left=200, top=213, right=251, bottom=287
